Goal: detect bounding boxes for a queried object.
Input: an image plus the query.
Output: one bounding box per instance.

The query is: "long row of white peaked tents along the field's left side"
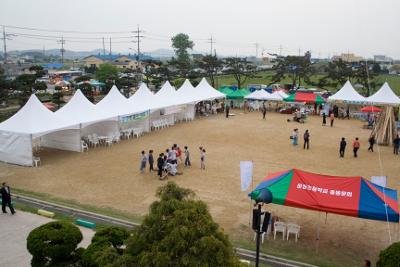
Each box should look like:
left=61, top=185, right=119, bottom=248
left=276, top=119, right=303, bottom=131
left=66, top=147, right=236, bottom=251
left=0, top=78, right=225, bottom=166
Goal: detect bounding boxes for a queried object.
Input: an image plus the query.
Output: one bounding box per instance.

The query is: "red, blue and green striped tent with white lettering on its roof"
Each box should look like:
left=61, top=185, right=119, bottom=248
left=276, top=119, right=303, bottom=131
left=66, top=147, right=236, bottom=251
left=249, top=169, right=399, bottom=223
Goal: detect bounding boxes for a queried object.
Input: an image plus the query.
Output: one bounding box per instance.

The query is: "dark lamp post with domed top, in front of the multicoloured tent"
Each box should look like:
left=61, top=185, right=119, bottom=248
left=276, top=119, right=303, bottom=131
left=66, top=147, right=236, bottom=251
left=251, top=188, right=272, bottom=267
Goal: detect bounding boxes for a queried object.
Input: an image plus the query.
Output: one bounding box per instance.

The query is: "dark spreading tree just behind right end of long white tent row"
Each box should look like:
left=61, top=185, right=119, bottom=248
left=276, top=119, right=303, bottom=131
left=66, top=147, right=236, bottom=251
left=224, top=57, right=255, bottom=88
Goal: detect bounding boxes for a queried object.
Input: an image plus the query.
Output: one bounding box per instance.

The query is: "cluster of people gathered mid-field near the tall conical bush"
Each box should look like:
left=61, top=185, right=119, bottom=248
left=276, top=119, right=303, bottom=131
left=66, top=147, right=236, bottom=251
left=140, top=144, right=206, bottom=179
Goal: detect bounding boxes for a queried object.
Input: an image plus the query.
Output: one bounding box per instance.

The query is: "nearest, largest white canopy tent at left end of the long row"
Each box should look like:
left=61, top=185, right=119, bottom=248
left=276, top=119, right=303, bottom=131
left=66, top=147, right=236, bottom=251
left=0, top=95, right=80, bottom=166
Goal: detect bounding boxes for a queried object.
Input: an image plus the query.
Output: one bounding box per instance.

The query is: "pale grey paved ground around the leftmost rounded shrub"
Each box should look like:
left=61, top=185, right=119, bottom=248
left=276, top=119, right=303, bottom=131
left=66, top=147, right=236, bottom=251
left=0, top=211, right=94, bottom=267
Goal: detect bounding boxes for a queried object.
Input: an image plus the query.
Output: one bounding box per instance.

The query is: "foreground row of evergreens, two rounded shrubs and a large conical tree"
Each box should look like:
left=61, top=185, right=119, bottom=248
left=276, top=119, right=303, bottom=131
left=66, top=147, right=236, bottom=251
left=27, top=182, right=242, bottom=267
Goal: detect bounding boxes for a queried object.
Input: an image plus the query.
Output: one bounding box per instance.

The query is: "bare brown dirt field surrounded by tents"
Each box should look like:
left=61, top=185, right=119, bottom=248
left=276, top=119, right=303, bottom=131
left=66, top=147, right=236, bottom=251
left=0, top=110, right=400, bottom=266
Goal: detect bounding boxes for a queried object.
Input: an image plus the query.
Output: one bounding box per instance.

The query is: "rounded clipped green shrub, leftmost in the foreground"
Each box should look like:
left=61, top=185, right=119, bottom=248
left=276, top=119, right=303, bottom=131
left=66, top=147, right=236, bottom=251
left=27, top=221, right=82, bottom=267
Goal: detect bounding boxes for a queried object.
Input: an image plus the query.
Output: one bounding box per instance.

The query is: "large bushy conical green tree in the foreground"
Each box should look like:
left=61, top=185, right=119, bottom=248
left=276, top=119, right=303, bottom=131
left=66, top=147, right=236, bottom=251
left=123, top=182, right=240, bottom=267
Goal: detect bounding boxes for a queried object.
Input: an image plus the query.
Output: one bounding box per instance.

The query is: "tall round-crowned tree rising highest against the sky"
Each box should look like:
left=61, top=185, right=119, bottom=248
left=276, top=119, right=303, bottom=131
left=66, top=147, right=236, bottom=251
left=170, top=33, right=194, bottom=77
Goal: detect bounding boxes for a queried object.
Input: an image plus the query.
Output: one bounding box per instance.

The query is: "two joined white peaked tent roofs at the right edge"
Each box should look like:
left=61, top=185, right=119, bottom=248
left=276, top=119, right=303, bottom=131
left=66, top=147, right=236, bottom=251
left=328, top=81, right=400, bottom=106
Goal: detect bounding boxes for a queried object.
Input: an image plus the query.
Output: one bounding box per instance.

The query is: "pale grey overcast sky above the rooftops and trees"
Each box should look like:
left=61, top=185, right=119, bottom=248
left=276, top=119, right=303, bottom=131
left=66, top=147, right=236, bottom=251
left=0, top=0, right=400, bottom=59
